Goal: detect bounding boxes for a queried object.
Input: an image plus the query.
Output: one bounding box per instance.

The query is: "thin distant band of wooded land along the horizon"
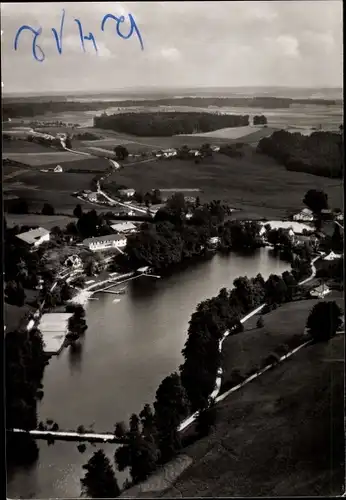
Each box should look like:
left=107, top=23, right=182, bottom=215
left=2, top=97, right=338, bottom=120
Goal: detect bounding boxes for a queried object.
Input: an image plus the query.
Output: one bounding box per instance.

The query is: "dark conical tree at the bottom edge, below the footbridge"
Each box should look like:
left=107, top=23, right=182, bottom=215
left=81, top=450, right=120, bottom=498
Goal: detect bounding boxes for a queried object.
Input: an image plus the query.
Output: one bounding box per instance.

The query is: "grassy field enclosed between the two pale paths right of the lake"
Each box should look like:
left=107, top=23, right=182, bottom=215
left=222, top=292, right=344, bottom=385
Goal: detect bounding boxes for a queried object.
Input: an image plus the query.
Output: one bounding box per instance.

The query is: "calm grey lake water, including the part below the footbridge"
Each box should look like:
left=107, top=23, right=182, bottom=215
left=7, top=248, right=290, bottom=498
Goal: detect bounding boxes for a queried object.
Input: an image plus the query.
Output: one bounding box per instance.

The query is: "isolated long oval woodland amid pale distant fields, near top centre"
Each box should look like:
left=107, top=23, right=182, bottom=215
left=94, top=112, right=249, bottom=137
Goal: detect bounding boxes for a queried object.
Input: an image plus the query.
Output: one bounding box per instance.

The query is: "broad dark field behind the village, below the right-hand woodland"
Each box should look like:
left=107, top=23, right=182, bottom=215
left=104, top=147, right=343, bottom=219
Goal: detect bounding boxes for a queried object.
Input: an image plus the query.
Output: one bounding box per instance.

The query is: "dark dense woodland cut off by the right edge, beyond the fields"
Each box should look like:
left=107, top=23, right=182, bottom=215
left=257, top=130, right=344, bottom=179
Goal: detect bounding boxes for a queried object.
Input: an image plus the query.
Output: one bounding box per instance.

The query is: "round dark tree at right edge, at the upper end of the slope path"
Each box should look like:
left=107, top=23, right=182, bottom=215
left=306, top=301, right=342, bottom=342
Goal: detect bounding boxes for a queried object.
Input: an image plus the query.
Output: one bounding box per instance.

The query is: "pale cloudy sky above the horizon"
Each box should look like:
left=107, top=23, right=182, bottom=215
left=1, top=0, right=343, bottom=93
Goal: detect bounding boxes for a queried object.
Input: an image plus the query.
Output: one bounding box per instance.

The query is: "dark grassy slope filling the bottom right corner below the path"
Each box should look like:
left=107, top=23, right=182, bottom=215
left=161, top=336, right=345, bottom=497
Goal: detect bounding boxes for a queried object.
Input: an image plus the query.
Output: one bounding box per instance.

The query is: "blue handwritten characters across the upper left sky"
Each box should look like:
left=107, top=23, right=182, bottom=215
left=14, top=9, right=144, bottom=62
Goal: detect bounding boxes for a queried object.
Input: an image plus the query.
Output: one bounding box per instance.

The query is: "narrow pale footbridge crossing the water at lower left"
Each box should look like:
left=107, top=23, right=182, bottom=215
left=6, top=429, right=127, bottom=444
